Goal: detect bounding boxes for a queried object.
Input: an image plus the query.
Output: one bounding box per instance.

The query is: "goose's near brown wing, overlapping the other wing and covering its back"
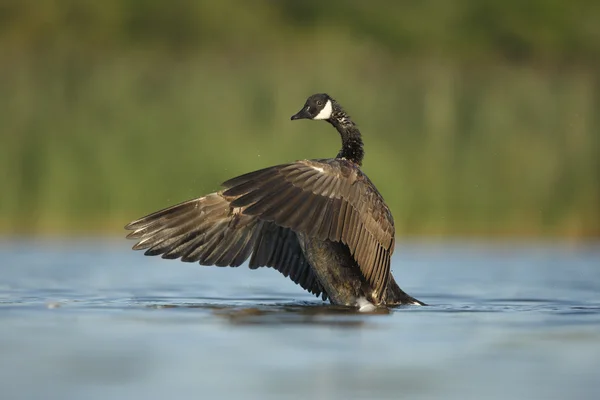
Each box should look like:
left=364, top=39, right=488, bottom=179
left=223, top=159, right=394, bottom=297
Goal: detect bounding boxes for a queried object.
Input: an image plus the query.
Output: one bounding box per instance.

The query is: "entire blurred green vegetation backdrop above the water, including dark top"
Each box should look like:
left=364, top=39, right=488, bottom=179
left=0, top=0, right=600, bottom=238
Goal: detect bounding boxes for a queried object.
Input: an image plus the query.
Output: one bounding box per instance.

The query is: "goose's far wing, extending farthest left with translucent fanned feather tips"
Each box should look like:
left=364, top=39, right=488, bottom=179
left=125, top=192, right=327, bottom=300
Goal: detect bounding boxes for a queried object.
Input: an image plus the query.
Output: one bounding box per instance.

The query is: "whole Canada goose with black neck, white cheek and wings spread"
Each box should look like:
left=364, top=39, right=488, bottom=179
left=125, top=94, right=424, bottom=311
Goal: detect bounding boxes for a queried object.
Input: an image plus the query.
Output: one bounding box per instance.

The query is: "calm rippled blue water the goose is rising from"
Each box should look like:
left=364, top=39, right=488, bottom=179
left=0, top=239, right=600, bottom=400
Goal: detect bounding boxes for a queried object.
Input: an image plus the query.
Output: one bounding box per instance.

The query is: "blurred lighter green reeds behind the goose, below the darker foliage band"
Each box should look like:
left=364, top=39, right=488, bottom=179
left=0, top=49, right=600, bottom=237
